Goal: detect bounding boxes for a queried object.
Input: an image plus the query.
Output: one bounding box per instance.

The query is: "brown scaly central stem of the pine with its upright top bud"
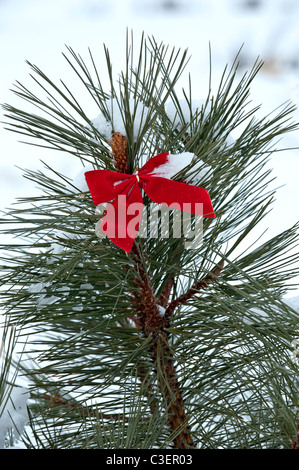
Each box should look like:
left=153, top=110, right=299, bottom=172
left=110, top=133, right=194, bottom=449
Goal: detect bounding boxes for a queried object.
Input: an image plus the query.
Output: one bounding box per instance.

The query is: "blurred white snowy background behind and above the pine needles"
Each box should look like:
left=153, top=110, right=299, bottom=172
left=0, top=0, right=299, bottom=448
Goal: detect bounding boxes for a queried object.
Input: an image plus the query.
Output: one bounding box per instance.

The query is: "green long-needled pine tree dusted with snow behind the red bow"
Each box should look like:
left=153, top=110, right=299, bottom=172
left=1, top=31, right=299, bottom=449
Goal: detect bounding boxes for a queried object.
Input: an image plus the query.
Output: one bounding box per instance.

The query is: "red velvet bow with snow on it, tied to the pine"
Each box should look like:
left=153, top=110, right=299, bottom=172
left=85, top=153, right=215, bottom=252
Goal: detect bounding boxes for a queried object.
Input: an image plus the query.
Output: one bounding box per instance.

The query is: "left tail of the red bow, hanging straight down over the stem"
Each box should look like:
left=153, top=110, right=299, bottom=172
left=100, top=182, right=143, bottom=253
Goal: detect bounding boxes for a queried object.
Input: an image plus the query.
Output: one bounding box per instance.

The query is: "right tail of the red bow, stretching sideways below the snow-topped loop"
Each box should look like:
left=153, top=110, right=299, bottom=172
left=142, top=175, right=215, bottom=218
